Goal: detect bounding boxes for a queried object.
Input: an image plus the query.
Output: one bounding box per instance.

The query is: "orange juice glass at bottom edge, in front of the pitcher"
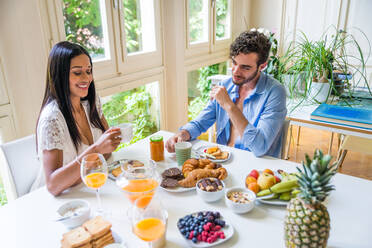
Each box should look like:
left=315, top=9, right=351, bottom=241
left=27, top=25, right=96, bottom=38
left=131, top=195, right=168, bottom=248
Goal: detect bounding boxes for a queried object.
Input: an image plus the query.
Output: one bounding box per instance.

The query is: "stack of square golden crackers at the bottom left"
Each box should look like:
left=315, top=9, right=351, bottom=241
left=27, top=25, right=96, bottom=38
left=61, top=216, right=115, bottom=248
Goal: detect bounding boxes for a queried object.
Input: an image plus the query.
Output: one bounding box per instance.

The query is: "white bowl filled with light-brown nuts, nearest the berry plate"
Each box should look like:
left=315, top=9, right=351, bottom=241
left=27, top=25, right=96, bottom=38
left=225, top=187, right=256, bottom=214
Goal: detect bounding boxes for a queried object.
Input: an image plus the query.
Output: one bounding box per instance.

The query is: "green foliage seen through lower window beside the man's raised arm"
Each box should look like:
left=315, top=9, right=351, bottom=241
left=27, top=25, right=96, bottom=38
left=188, top=62, right=226, bottom=120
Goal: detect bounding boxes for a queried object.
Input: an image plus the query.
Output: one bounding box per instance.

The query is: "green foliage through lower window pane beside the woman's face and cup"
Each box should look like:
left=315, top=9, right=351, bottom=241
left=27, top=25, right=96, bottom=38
left=102, top=86, right=159, bottom=149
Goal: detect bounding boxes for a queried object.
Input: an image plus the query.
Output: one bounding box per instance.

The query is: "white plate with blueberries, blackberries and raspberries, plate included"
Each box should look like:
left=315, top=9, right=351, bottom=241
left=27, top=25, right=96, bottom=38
left=177, top=211, right=234, bottom=248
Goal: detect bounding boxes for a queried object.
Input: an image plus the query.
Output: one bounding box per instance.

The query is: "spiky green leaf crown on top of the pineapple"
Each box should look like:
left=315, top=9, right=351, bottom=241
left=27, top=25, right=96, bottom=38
left=296, top=149, right=337, bottom=205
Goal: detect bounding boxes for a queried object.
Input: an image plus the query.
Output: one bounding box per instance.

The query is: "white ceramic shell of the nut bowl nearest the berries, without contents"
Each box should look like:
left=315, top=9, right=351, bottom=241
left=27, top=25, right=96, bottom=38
left=225, top=187, right=256, bottom=214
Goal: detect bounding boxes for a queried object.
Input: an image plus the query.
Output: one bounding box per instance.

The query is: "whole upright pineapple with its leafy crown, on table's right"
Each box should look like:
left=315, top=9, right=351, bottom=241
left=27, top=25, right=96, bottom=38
left=284, top=150, right=337, bottom=248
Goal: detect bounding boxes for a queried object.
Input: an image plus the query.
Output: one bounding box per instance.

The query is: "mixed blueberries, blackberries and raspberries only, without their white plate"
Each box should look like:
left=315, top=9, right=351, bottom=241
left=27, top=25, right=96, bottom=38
left=177, top=211, right=226, bottom=244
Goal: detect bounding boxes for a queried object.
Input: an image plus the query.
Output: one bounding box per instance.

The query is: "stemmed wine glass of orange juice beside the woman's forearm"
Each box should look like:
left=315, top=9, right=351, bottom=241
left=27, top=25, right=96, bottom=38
left=80, top=153, right=108, bottom=215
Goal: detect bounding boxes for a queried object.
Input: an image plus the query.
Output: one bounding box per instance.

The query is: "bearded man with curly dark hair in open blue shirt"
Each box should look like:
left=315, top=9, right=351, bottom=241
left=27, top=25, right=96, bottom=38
left=166, top=31, right=287, bottom=157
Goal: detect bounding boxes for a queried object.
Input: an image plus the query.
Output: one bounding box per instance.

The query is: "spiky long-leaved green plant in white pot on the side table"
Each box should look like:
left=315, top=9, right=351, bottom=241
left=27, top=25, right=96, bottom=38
left=287, top=27, right=372, bottom=103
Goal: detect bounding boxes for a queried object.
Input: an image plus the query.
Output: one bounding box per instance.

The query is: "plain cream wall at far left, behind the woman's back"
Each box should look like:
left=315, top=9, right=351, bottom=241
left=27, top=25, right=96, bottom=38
left=0, top=0, right=47, bottom=137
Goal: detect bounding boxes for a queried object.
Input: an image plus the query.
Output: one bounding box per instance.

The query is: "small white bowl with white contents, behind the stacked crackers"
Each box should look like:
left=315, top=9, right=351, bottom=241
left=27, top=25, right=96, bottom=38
left=57, top=200, right=90, bottom=229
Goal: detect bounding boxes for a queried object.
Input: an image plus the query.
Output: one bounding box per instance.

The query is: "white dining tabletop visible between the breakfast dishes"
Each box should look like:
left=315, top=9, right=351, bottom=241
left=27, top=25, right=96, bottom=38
left=0, top=131, right=372, bottom=248
